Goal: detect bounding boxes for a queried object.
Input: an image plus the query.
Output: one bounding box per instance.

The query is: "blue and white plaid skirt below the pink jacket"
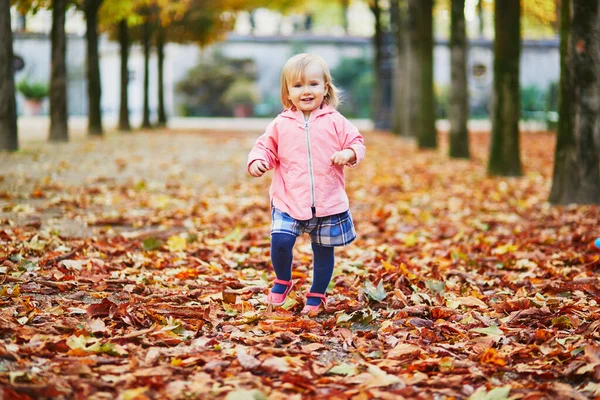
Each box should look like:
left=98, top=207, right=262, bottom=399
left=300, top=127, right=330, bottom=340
left=271, top=207, right=356, bottom=247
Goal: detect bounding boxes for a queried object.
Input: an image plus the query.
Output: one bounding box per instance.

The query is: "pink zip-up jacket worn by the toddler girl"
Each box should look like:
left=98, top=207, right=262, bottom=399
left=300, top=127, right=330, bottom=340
left=248, top=106, right=365, bottom=220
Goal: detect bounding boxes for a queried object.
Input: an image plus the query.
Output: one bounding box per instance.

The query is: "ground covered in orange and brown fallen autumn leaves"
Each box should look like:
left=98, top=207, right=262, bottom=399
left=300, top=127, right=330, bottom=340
left=0, top=132, right=600, bottom=400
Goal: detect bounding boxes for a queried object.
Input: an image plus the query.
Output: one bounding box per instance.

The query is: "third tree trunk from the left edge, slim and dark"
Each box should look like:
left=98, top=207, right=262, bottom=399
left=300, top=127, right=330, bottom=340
left=84, top=0, right=103, bottom=136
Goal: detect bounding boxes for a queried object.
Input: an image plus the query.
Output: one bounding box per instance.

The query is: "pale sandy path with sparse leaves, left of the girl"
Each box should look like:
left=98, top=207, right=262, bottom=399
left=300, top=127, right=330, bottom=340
left=0, top=125, right=260, bottom=237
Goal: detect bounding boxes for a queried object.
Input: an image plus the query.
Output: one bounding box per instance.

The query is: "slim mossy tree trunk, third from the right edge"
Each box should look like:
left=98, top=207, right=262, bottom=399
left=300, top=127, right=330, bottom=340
left=448, top=0, right=469, bottom=158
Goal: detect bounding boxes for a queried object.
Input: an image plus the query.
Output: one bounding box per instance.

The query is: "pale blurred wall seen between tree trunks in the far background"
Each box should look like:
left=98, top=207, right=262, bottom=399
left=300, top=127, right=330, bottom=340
left=14, top=33, right=560, bottom=124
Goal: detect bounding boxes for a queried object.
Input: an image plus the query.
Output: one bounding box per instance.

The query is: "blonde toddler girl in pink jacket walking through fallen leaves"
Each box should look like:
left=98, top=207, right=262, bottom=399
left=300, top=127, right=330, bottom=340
left=248, top=53, right=365, bottom=314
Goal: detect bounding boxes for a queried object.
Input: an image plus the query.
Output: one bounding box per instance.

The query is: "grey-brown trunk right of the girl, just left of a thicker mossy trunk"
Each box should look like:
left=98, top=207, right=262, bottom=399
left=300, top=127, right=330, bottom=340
left=390, top=0, right=410, bottom=136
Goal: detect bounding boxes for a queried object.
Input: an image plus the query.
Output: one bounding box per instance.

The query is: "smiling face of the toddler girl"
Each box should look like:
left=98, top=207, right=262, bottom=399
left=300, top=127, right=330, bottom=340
left=287, top=62, right=327, bottom=117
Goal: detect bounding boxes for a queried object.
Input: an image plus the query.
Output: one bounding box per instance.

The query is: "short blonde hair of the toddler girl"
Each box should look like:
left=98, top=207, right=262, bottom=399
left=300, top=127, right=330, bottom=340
left=281, top=53, right=340, bottom=109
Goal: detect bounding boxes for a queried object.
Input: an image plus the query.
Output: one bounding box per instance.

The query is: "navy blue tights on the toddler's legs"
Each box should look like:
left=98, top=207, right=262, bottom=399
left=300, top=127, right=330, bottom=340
left=271, top=233, right=334, bottom=306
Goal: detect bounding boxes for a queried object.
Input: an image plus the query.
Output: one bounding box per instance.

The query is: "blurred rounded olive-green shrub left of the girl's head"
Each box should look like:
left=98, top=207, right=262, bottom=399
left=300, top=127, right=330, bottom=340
left=176, top=52, right=258, bottom=117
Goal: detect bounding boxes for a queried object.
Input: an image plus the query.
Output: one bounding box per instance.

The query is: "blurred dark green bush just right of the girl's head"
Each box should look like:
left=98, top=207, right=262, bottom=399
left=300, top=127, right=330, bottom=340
left=331, top=57, right=373, bottom=118
